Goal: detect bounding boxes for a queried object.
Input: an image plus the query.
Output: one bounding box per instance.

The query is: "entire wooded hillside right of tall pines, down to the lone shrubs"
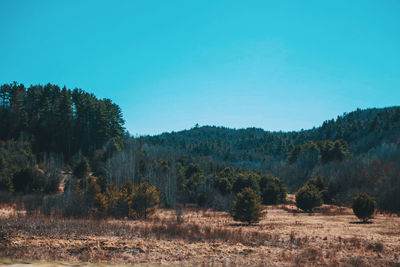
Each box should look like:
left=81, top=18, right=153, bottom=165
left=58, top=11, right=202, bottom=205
left=142, top=107, right=400, bottom=213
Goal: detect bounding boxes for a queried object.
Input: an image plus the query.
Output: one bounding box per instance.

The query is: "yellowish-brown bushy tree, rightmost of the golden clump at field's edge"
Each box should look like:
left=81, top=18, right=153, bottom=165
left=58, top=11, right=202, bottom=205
left=131, top=182, right=160, bottom=219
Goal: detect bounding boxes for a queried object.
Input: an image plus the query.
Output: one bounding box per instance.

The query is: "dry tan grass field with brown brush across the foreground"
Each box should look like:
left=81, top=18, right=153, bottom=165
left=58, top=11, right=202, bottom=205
left=0, top=198, right=400, bottom=266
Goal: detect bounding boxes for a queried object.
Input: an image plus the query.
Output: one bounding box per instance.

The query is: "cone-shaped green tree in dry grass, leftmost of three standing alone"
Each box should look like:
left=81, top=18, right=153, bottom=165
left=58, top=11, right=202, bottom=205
left=232, top=187, right=263, bottom=224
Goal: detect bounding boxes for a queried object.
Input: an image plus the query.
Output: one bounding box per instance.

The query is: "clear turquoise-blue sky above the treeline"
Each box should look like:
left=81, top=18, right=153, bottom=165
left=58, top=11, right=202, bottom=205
left=0, top=0, right=400, bottom=134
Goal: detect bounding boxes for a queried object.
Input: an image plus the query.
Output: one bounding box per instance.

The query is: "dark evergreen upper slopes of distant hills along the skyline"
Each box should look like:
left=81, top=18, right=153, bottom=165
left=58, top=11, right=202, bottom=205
left=144, top=107, right=400, bottom=169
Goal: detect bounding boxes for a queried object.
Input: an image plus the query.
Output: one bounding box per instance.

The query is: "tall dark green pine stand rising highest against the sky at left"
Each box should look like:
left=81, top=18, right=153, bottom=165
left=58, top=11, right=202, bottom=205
left=0, top=83, right=124, bottom=160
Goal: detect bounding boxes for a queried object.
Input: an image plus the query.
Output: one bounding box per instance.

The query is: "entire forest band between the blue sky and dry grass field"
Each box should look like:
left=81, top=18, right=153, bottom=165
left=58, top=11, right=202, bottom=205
left=0, top=82, right=400, bottom=219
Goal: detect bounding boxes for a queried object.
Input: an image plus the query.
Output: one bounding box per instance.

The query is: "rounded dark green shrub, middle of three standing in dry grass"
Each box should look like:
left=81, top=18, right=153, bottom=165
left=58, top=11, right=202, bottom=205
left=296, top=185, right=322, bottom=212
